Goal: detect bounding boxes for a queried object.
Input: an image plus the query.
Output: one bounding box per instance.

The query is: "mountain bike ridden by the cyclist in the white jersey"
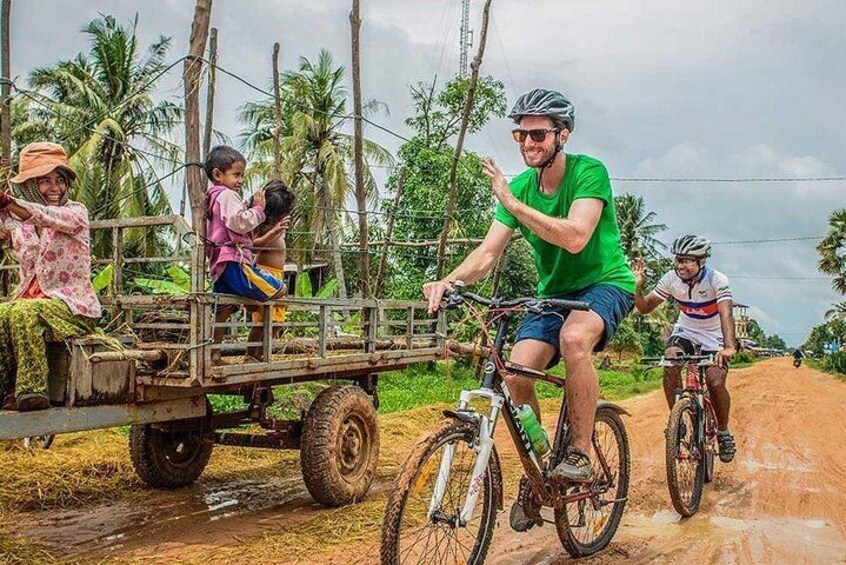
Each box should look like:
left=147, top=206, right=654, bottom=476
left=644, top=355, right=719, bottom=517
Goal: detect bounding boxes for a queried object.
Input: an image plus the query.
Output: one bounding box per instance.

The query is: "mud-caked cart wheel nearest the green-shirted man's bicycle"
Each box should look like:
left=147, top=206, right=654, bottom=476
left=300, top=385, right=379, bottom=506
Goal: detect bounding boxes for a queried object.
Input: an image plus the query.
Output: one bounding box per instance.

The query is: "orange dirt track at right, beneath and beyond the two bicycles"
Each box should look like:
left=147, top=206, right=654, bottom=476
left=487, top=358, right=846, bottom=564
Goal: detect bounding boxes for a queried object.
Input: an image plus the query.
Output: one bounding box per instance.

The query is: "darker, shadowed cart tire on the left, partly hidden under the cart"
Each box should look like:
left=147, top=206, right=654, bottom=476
left=129, top=421, right=214, bottom=489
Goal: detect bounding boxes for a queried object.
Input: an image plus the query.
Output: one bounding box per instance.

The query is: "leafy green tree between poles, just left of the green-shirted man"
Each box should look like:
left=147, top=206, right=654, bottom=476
left=382, top=77, right=510, bottom=298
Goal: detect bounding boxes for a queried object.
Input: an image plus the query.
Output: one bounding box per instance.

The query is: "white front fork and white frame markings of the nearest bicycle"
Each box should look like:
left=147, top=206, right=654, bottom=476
left=429, top=383, right=540, bottom=526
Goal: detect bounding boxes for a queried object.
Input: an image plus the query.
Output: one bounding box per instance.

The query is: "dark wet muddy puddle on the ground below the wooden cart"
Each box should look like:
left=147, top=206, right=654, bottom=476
left=22, top=477, right=315, bottom=556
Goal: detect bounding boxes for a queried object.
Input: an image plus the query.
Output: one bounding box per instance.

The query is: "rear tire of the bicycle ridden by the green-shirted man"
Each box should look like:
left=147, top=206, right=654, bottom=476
left=555, top=407, right=631, bottom=558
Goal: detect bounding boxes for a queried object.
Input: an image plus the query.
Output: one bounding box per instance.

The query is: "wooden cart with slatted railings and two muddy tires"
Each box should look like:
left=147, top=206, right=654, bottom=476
left=0, top=215, right=446, bottom=506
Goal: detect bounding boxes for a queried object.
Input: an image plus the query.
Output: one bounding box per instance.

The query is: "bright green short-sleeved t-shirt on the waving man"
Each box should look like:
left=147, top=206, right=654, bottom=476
left=494, top=154, right=635, bottom=298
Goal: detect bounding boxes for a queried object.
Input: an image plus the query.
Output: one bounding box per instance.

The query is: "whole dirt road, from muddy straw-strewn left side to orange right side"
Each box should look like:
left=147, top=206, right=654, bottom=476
left=6, top=359, right=846, bottom=564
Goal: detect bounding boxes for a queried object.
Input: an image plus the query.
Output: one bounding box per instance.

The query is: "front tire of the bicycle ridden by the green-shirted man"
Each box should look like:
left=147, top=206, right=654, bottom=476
left=380, top=420, right=502, bottom=565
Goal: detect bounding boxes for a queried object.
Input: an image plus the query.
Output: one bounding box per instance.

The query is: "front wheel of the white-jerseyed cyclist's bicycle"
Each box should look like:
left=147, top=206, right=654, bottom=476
left=665, top=398, right=705, bottom=517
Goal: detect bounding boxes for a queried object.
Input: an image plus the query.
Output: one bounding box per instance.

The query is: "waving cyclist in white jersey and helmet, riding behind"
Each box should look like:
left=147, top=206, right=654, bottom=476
left=633, top=235, right=737, bottom=463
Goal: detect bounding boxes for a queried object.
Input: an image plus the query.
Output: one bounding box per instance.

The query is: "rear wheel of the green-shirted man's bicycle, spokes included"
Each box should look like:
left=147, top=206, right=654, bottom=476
left=555, top=407, right=631, bottom=557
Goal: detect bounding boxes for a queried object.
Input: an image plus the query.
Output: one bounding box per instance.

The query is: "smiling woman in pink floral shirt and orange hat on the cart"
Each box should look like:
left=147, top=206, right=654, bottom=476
left=0, top=143, right=101, bottom=411
